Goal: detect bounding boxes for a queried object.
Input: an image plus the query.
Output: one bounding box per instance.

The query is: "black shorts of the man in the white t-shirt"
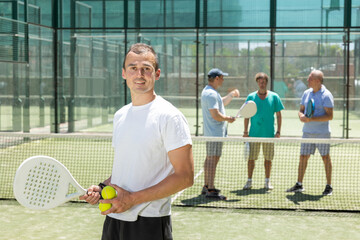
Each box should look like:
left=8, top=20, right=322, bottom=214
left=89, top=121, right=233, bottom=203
left=101, top=216, right=173, bottom=240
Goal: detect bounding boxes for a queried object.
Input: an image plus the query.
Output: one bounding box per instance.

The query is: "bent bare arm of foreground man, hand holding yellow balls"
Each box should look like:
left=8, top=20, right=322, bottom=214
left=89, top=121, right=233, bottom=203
left=100, top=144, right=194, bottom=215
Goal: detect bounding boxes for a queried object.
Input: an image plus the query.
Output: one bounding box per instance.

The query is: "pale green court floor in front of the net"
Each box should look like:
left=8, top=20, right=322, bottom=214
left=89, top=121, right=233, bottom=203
left=0, top=200, right=360, bottom=240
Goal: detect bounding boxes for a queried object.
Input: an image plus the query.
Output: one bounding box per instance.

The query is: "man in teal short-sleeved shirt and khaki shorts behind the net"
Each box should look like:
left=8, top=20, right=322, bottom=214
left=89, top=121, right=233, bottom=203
left=243, top=73, right=284, bottom=190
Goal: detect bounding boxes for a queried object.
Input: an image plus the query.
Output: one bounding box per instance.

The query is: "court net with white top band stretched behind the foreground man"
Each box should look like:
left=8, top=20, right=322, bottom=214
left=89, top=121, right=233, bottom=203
left=0, top=133, right=360, bottom=211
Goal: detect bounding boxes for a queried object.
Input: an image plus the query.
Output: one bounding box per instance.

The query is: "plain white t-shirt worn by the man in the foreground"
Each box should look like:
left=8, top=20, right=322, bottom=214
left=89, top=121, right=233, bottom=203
left=108, top=96, right=192, bottom=221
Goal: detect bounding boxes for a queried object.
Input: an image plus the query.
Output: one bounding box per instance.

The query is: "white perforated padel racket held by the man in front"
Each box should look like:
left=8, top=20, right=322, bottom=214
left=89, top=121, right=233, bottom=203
left=14, top=156, right=86, bottom=210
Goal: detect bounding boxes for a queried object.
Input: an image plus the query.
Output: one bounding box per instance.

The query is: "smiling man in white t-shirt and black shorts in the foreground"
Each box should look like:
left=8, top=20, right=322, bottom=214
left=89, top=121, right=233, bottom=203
left=80, top=43, right=194, bottom=240
